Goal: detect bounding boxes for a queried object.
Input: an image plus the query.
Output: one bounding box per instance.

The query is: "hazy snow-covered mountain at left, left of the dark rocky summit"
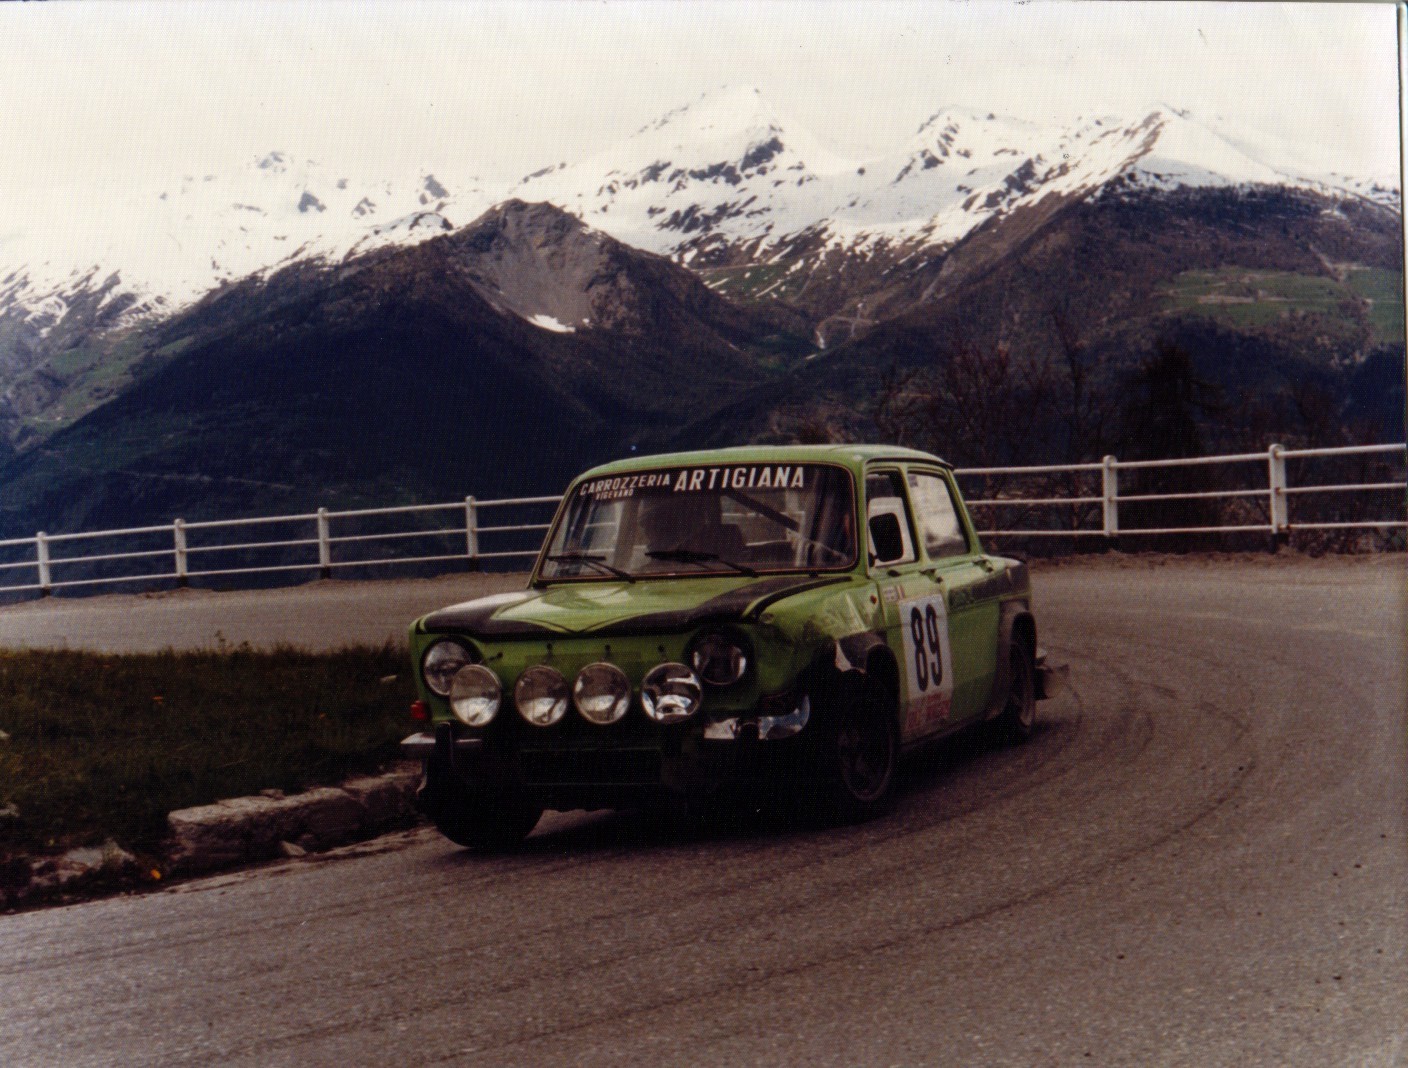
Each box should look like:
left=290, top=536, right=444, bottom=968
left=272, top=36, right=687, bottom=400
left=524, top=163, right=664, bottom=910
left=0, top=152, right=494, bottom=335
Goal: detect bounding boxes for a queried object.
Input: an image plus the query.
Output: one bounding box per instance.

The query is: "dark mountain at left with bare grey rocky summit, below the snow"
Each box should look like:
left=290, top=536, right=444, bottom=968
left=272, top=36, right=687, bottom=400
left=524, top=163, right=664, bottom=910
left=0, top=203, right=811, bottom=530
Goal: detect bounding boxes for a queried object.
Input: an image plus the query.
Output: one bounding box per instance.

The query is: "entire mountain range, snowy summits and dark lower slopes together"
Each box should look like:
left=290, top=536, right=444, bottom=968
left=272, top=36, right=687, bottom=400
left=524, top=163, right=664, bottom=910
left=0, top=90, right=1402, bottom=543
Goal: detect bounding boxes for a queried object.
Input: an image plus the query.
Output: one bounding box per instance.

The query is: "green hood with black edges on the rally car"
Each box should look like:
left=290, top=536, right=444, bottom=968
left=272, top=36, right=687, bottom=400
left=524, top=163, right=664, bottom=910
left=420, top=574, right=850, bottom=639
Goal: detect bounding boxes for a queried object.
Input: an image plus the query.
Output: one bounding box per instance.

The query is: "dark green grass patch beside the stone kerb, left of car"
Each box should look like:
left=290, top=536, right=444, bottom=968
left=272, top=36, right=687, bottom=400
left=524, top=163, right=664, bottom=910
left=0, top=646, right=414, bottom=856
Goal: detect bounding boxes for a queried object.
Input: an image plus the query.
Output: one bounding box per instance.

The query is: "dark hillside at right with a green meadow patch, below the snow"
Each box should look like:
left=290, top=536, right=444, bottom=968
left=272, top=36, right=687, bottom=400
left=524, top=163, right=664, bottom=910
left=675, top=190, right=1402, bottom=463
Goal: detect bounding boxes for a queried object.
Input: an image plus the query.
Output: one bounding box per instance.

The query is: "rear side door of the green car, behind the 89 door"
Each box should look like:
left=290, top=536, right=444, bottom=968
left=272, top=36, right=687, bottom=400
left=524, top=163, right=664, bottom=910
left=905, top=466, right=1001, bottom=723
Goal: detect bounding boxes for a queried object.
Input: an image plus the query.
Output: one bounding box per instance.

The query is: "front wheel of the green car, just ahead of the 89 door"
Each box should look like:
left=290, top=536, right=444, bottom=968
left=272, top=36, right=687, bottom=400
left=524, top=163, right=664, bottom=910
left=824, top=675, right=900, bottom=823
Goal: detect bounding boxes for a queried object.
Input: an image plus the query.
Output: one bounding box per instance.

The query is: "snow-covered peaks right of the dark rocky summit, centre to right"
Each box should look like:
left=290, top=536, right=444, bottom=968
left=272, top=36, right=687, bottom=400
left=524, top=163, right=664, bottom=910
left=514, top=90, right=1398, bottom=266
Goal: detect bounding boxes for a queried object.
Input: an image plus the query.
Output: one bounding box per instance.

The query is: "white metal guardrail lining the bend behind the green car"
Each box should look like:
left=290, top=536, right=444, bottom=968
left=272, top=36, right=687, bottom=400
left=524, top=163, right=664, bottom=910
left=0, top=443, right=1408, bottom=594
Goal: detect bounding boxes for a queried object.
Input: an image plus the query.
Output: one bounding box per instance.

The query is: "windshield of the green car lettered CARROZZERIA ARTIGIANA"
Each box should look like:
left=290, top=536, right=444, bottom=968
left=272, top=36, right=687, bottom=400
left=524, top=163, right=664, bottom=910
left=539, top=463, right=856, bottom=580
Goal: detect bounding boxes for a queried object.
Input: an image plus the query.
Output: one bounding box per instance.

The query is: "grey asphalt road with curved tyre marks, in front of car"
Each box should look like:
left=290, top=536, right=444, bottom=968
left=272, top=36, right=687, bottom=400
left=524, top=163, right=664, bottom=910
left=0, top=557, right=1408, bottom=1065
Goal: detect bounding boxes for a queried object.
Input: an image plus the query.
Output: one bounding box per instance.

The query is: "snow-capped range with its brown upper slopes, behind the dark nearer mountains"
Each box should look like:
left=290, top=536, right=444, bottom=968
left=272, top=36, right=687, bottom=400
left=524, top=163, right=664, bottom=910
left=0, top=89, right=1400, bottom=442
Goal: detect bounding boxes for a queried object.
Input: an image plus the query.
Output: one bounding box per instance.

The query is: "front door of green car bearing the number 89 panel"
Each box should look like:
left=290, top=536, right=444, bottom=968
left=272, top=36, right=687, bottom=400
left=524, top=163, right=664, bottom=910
left=866, top=466, right=953, bottom=743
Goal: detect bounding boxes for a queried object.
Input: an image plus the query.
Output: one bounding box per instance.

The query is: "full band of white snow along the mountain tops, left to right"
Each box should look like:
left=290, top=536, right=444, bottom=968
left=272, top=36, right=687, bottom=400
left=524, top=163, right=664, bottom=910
left=0, top=89, right=1398, bottom=346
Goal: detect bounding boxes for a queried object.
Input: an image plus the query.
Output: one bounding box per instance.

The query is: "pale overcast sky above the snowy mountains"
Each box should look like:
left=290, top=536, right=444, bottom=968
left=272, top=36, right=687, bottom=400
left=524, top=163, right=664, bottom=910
left=0, top=0, right=1400, bottom=199
